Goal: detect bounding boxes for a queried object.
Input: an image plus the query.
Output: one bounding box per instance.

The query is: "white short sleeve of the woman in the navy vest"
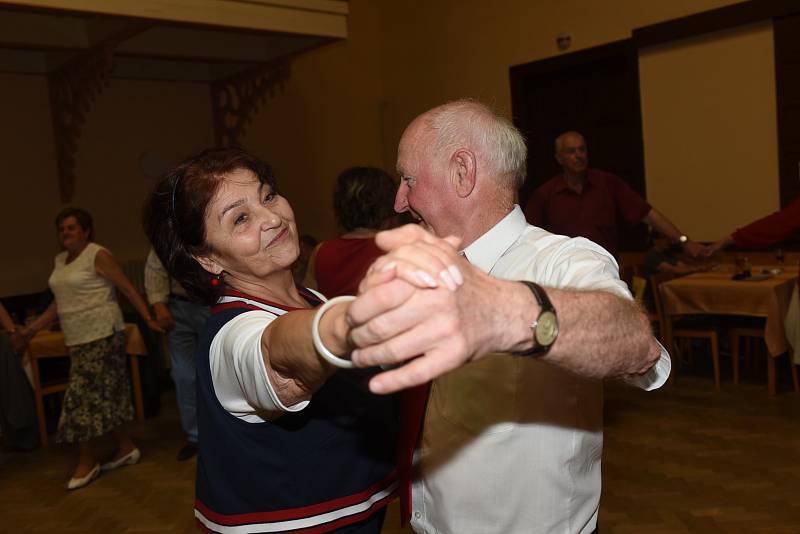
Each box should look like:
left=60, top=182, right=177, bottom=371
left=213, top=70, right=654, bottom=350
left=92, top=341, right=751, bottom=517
left=209, top=310, right=309, bottom=423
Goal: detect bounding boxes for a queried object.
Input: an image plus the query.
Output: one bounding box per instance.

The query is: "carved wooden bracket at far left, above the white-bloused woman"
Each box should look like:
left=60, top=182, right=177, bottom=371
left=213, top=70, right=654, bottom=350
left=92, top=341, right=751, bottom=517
left=47, top=22, right=148, bottom=202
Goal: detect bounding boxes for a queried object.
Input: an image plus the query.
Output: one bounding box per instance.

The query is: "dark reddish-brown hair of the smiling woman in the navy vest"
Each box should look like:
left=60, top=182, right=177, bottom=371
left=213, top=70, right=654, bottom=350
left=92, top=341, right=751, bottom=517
left=142, top=148, right=276, bottom=305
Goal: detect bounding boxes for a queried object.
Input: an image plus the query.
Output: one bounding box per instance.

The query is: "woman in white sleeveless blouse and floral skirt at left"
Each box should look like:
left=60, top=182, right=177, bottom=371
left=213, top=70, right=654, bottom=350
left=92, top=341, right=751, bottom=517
left=23, top=208, right=162, bottom=490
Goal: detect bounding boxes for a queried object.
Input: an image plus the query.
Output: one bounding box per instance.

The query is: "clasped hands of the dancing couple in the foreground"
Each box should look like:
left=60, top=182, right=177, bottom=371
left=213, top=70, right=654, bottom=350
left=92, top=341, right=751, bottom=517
left=347, top=225, right=489, bottom=393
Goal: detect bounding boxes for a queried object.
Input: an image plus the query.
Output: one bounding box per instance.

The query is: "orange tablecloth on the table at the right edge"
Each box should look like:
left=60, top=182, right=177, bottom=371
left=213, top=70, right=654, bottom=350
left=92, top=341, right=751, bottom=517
left=661, top=268, right=797, bottom=356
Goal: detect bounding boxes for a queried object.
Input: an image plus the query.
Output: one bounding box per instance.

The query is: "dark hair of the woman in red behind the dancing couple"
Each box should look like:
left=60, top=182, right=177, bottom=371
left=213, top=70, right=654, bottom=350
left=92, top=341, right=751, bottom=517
left=333, top=167, right=397, bottom=232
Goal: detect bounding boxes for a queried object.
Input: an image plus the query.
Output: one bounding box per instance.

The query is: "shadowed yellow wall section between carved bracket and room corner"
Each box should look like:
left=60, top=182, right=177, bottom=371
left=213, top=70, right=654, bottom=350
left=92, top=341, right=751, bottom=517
left=248, top=2, right=394, bottom=242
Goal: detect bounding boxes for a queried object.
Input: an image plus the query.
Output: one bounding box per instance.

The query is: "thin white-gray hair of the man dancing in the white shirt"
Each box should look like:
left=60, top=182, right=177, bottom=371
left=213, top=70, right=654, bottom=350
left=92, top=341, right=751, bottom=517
left=425, top=99, right=527, bottom=189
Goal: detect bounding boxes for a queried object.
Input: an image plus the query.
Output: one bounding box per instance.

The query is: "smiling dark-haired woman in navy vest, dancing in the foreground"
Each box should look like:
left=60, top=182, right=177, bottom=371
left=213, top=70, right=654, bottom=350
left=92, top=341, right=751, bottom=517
left=144, top=149, right=450, bottom=533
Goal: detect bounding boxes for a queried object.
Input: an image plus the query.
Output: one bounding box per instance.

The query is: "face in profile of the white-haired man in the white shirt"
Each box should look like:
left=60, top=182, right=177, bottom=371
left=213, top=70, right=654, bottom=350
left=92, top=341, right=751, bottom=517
left=394, top=120, right=449, bottom=239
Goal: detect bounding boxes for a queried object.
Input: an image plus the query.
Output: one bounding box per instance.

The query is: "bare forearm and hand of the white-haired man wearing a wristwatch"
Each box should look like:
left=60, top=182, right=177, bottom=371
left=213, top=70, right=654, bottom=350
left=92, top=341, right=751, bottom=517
left=348, top=225, right=661, bottom=393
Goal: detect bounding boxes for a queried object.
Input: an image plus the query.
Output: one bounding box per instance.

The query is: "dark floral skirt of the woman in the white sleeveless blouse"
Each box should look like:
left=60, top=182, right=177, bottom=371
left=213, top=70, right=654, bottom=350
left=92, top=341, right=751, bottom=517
left=56, top=332, right=133, bottom=443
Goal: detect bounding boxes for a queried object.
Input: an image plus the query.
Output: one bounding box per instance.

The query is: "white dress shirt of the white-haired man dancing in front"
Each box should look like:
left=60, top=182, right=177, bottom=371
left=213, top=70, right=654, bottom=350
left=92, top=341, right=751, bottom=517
left=411, top=206, right=670, bottom=534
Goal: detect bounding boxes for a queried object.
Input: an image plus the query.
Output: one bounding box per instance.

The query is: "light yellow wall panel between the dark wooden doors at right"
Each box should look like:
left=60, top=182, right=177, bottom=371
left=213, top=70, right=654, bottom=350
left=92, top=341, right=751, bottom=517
left=639, top=23, right=779, bottom=240
